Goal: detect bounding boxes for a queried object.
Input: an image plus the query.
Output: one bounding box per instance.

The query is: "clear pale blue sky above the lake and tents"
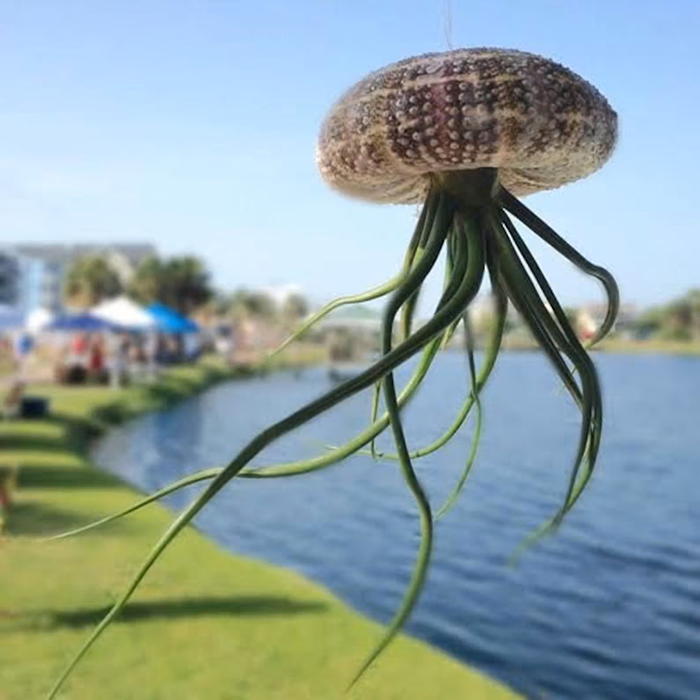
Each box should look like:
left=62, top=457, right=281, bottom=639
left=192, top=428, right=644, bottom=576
left=0, top=0, right=700, bottom=304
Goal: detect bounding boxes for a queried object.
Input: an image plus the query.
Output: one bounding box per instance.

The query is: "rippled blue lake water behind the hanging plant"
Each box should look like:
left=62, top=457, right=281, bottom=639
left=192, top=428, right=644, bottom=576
left=96, top=353, right=700, bottom=700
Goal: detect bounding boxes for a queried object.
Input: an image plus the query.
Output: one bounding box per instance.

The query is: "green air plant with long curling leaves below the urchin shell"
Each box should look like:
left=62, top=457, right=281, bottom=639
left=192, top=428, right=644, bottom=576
left=46, top=171, right=619, bottom=700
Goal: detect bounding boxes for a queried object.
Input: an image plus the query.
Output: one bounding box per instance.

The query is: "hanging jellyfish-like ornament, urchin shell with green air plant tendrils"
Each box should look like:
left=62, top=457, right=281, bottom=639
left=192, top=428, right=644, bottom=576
left=49, top=49, right=619, bottom=698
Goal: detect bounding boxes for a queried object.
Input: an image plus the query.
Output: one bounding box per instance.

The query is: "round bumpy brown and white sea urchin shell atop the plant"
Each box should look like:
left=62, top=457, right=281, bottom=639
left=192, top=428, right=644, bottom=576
left=317, top=48, right=617, bottom=203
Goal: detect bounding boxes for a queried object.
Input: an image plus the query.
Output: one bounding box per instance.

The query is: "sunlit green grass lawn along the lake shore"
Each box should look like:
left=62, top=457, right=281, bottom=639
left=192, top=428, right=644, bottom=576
left=0, top=364, right=516, bottom=700
